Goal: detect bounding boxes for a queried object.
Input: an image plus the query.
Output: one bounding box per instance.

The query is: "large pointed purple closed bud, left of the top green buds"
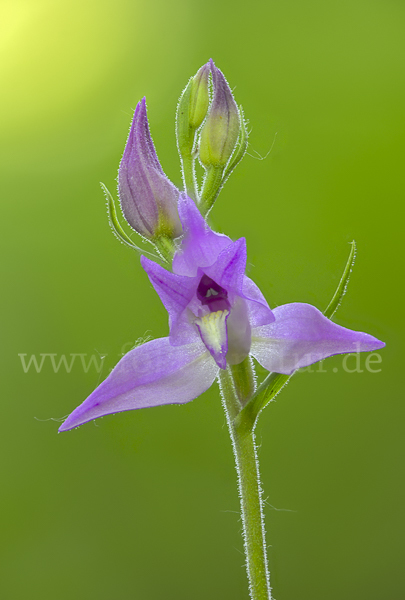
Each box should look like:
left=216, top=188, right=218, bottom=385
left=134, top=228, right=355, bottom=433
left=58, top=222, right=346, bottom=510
left=118, top=98, right=182, bottom=241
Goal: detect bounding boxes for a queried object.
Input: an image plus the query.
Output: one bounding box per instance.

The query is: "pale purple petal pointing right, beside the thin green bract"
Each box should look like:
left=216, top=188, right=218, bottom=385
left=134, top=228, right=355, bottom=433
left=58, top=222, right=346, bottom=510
left=251, top=302, right=385, bottom=375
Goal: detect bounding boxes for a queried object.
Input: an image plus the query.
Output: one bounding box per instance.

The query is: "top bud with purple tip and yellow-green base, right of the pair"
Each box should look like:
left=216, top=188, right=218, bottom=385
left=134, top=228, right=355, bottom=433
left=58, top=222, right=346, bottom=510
left=199, top=59, right=240, bottom=168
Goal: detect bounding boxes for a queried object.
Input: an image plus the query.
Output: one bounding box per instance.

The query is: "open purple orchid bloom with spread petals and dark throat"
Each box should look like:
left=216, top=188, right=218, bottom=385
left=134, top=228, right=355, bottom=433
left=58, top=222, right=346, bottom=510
left=59, top=197, right=384, bottom=431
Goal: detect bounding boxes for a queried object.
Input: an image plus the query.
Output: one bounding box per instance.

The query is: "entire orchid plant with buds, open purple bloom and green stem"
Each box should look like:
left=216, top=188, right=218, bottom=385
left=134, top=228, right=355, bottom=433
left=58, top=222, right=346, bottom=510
left=59, top=60, right=384, bottom=600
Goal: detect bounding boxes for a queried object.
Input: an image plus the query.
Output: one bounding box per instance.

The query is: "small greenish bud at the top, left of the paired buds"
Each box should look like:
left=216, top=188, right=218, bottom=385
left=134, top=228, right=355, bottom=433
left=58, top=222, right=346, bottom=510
left=176, top=63, right=210, bottom=155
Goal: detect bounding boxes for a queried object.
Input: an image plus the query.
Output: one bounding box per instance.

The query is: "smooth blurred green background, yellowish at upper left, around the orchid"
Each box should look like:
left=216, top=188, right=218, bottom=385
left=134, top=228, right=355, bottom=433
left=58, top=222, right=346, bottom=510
left=0, top=0, right=405, bottom=600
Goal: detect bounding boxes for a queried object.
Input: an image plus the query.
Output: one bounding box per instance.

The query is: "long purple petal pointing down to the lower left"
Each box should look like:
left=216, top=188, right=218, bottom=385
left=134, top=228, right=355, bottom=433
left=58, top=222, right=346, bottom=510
left=59, top=338, right=218, bottom=431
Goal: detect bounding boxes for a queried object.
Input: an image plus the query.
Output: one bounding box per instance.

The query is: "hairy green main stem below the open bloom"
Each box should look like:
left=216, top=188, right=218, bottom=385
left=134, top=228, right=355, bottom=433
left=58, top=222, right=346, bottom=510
left=219, top=368, right=271, bottom=600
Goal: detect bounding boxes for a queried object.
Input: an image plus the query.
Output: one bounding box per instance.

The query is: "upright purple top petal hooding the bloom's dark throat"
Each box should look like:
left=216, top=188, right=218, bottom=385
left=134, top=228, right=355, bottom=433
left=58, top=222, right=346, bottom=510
left=173, top=195, right=232, bottom=277
